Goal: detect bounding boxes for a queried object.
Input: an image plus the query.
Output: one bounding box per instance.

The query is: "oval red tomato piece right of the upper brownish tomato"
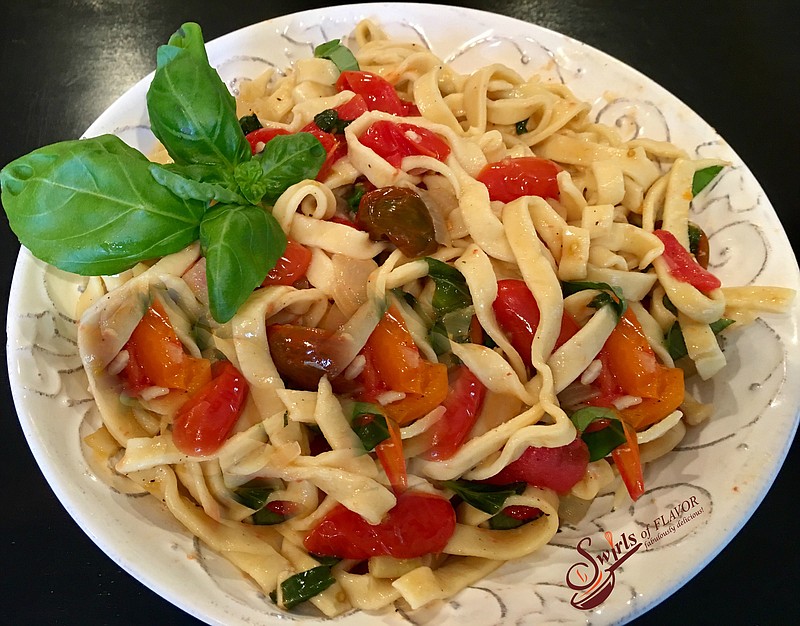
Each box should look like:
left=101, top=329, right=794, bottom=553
left=477, top=157, right=561, bottom=203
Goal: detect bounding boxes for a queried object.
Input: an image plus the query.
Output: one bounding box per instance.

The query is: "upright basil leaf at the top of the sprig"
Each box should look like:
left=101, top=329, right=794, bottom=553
left=147, top=22, right=251, bottom=169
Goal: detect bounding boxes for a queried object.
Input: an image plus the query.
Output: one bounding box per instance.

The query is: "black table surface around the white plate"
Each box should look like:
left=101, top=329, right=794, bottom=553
left=0, top=0, right=800, bottom=626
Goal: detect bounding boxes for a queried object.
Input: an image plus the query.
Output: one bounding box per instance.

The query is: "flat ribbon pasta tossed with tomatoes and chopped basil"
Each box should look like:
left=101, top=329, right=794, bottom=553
left=73, top=21, right=793, bottom=616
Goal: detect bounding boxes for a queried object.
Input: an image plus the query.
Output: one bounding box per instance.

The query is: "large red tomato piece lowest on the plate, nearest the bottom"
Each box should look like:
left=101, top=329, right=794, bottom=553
left=303, top=491, right=456, bottom=560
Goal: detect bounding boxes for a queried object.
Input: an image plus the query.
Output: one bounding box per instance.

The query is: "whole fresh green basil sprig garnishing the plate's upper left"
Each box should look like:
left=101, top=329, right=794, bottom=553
left=0, top=23, right=325, bottom=322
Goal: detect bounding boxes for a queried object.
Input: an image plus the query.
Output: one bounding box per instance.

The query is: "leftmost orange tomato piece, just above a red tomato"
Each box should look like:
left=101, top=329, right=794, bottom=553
left=120, top=300, right=211, bottom=396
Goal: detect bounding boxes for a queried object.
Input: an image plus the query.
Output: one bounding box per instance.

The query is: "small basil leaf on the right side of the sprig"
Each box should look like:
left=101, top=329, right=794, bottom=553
left=255, top=133, right=326, bottom=204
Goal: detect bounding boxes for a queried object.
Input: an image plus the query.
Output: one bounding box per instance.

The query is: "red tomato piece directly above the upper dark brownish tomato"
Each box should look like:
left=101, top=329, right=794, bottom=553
left=358, top=120, right=450, bottom=168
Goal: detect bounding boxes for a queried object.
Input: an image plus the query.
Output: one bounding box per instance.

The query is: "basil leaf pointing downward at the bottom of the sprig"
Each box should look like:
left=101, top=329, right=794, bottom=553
left=200, top=204, right=286, bottom=323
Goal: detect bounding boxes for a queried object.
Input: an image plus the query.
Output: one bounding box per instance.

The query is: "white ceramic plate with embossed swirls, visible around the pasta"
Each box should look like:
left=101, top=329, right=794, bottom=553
left=8, top=4, right=800, bottom=626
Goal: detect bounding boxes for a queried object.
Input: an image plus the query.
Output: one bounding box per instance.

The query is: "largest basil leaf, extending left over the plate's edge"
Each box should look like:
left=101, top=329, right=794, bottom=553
left=0, top=135, right=206, bottom=275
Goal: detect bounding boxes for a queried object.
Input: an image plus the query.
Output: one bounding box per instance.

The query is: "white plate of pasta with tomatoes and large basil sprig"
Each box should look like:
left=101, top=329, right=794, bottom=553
left=0, top=3, right=800, bottom=625
